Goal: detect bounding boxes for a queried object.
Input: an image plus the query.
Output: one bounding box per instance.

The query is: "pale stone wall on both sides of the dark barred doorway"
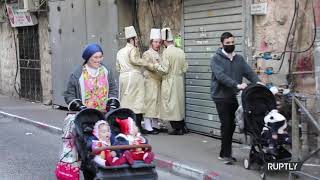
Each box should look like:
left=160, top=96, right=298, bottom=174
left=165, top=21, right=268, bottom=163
left=0, top=5, right=52, bottom=104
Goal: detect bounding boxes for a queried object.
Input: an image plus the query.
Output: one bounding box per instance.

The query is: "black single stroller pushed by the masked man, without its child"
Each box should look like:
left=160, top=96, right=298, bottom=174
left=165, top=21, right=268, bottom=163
left=241, top=84, right=291, bottom=179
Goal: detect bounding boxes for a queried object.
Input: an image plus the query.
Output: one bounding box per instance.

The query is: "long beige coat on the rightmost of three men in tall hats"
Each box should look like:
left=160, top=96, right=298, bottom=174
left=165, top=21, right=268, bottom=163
left=155, top=45, right=188, bottom=121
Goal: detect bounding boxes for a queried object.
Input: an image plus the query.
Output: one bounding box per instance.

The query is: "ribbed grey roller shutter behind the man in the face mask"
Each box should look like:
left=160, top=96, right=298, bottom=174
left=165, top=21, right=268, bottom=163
left=183, top=0, right=244, bottom=139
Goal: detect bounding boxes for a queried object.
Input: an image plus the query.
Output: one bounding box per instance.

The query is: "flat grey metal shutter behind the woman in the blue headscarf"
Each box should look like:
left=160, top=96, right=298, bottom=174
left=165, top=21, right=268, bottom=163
left=49, top=0, right=118, bottom=106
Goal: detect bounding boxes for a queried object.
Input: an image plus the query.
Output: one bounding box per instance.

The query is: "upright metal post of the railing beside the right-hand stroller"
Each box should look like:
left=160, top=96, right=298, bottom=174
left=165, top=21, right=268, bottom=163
left=292, top=95, right=300, bottom=161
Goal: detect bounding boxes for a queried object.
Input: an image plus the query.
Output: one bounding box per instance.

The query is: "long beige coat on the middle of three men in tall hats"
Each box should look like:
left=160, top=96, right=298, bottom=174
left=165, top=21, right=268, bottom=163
left=142, top=48, right=161, bottom=118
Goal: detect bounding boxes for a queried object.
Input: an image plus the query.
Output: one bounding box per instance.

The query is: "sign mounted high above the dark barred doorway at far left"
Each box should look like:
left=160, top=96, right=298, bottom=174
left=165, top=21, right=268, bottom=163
left=7, top=4, right=38, bottom=27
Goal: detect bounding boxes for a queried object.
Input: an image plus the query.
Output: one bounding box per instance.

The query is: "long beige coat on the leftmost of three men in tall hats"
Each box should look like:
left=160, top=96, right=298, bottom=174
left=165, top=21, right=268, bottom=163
left=116, top=43, right=152, bottom=114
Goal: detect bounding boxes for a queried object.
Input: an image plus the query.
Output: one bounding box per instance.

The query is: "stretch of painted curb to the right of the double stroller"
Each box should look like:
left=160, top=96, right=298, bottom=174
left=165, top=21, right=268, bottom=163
left=155, top=158, right=221, bottom=180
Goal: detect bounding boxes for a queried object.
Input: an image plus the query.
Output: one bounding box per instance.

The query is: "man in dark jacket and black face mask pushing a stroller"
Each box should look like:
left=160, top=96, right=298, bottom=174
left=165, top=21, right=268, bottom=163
left=211, top=32, right=260, bottom=164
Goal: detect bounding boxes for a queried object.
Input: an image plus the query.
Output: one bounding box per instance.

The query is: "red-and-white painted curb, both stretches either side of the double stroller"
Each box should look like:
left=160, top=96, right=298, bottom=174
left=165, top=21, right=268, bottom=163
left=0, top=111, right=220, bottom=180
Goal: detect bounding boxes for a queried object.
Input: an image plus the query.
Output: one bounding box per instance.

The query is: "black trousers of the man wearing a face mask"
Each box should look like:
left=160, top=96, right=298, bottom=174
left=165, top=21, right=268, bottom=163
left=215, top=99, right=238, bottom=157
